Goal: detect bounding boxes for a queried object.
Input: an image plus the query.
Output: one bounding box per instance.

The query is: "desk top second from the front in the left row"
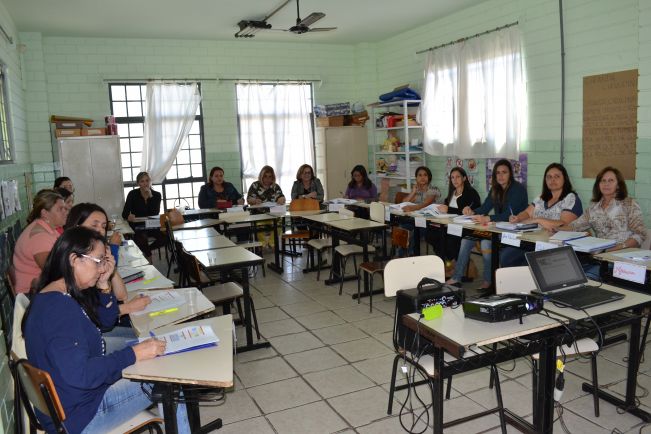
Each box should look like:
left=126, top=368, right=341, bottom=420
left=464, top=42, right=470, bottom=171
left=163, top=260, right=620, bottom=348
left=129, top=288, right=215, bottom=336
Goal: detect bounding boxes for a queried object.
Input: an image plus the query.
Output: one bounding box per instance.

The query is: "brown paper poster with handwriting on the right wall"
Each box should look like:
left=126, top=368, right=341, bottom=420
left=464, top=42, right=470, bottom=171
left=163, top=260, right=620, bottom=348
left=583, top=69, right=638, bottom=179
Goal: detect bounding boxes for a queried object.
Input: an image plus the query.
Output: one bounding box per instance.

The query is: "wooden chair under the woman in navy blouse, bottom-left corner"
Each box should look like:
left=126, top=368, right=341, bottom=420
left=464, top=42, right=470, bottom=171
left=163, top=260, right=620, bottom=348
left=12, top=354, right=163, bottom=434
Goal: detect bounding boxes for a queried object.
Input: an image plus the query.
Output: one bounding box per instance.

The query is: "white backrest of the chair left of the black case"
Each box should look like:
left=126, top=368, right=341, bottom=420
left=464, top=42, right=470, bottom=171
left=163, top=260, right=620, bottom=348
left=384, top=255, right=445, bottom=297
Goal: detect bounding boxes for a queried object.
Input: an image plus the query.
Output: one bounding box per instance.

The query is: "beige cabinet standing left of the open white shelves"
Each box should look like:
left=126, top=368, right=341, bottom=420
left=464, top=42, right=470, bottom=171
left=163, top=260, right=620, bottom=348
left=314, top=126, right=368, bottom=199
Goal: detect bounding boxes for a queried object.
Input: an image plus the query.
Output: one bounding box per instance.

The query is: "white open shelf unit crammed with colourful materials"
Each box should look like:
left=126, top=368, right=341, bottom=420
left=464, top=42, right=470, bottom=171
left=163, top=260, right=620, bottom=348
left=370, top=100, right=425, bottom=195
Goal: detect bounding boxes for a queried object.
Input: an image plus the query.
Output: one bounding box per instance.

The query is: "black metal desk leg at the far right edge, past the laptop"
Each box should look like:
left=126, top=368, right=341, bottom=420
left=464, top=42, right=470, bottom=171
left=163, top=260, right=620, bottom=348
left=582, top=312, right=651, bottom=422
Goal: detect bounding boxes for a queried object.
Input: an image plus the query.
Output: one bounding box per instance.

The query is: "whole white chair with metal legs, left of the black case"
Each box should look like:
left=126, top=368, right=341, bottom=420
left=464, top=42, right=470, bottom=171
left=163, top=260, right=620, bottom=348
left=384, top=255, right=506, bottom=433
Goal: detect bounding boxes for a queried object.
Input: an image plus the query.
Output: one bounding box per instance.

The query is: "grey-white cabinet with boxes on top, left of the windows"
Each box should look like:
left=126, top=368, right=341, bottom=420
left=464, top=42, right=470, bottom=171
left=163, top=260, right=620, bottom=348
left=58, top=136, right=124, bottom=217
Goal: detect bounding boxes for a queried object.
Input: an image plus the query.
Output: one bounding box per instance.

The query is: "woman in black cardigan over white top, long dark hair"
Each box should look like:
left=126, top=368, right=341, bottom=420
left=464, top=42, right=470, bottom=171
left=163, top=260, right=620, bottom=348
left=434, top=167, right=481, bottom=261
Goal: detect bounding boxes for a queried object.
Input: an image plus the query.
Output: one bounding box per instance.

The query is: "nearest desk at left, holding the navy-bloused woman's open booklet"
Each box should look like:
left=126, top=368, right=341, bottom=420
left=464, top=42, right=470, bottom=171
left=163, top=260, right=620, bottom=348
left=122, top=315, right=233, bottom=433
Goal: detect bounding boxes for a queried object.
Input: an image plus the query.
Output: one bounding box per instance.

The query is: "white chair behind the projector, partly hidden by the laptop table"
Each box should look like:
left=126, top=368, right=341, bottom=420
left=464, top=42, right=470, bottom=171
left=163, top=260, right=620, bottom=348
left=495, top=266, right=599, bottom=417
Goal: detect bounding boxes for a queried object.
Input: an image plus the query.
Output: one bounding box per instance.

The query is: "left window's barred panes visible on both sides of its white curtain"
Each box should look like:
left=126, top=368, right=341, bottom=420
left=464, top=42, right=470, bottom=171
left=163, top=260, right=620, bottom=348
left=109, top=83, right=206, bottom=209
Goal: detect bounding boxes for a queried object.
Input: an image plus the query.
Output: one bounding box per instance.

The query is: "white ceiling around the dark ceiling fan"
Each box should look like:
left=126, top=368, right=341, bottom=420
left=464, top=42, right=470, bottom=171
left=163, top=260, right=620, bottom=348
left=0, top=0, right=484, bottom=44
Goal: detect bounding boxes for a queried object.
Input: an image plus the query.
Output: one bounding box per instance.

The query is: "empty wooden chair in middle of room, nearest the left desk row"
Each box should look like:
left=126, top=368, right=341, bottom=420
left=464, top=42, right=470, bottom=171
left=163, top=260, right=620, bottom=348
left=178, top=244, right=260, bottom=339
